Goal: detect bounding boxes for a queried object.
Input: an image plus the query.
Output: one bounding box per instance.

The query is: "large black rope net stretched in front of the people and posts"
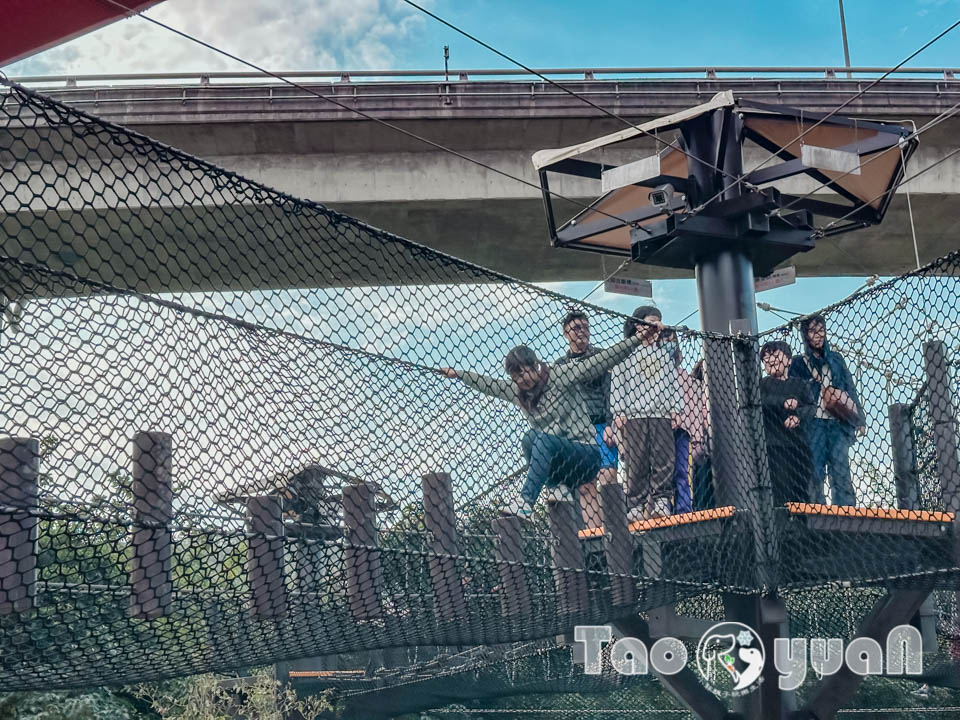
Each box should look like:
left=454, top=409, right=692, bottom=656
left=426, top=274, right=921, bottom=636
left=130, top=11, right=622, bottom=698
left=0, top=80, right=960, bottom=704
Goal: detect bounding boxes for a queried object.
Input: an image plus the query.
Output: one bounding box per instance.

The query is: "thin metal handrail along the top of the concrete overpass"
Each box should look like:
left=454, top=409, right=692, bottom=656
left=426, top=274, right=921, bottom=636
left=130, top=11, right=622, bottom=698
left=13, top=65, right=960, bottom=86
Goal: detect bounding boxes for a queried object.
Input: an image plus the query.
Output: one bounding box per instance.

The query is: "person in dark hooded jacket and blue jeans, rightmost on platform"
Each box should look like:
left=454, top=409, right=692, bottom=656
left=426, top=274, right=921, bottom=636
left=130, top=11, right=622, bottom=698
left=790, top=315, right=866, bottom=505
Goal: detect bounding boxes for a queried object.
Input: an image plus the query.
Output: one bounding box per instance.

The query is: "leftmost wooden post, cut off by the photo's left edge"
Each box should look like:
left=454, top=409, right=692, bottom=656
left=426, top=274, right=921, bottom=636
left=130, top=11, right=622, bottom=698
left=0, top=437, right=40, bottom=615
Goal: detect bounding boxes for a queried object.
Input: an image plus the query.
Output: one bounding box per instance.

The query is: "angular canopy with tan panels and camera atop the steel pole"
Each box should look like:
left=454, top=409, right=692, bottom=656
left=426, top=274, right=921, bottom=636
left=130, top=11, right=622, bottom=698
left=533, top=92, right=917, bottom=275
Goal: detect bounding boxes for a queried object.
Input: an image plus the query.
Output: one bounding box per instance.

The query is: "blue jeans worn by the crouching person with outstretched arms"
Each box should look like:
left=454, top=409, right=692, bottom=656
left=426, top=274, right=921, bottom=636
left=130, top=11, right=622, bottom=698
left=520, top=428, right=600, bottom=505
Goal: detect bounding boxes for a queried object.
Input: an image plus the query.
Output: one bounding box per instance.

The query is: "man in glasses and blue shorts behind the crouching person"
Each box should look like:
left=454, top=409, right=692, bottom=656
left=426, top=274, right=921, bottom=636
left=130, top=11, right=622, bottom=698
left=554, top=309, right=617, bottom=528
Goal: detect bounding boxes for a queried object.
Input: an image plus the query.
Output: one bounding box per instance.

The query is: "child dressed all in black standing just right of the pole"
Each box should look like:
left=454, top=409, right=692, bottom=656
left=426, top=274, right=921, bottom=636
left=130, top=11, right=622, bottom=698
left=760, top=340, right=816, bottom=505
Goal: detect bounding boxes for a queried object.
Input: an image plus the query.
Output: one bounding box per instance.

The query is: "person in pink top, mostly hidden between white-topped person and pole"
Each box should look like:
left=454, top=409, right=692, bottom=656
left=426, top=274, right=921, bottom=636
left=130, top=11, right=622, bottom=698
left=660, top=329, right=706, bottom=513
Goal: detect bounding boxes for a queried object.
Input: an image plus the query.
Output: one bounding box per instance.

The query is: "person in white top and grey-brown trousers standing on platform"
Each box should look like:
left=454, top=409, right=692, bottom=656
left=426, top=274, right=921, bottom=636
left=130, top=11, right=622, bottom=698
left=610, top=305, right=681, bottom=520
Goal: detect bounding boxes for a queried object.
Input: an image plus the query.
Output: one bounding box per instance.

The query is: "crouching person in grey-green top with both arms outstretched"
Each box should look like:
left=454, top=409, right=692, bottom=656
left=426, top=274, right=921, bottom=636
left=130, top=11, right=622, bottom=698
left=440, top=330, right=640, bottom=518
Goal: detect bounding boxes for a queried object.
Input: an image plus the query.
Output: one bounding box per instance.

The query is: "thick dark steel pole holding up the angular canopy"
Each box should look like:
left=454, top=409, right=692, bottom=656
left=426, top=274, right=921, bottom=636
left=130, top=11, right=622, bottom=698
left=683, top=109, right=793, bottom=720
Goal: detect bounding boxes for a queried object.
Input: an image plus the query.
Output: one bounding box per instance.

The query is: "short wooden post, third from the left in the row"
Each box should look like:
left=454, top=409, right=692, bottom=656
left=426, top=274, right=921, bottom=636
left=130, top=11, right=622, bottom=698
left=247, top=495, right=287, bottom=618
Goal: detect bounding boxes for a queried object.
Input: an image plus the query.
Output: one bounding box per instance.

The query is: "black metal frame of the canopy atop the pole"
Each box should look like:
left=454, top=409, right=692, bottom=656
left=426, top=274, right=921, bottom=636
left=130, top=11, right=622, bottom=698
left=539, top=98, right=917, bottom=275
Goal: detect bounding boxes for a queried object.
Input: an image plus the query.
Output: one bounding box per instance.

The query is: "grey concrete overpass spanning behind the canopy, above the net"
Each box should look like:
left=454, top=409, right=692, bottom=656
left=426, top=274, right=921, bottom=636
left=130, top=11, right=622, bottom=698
left=7, top=68, right=960, bottom=283
